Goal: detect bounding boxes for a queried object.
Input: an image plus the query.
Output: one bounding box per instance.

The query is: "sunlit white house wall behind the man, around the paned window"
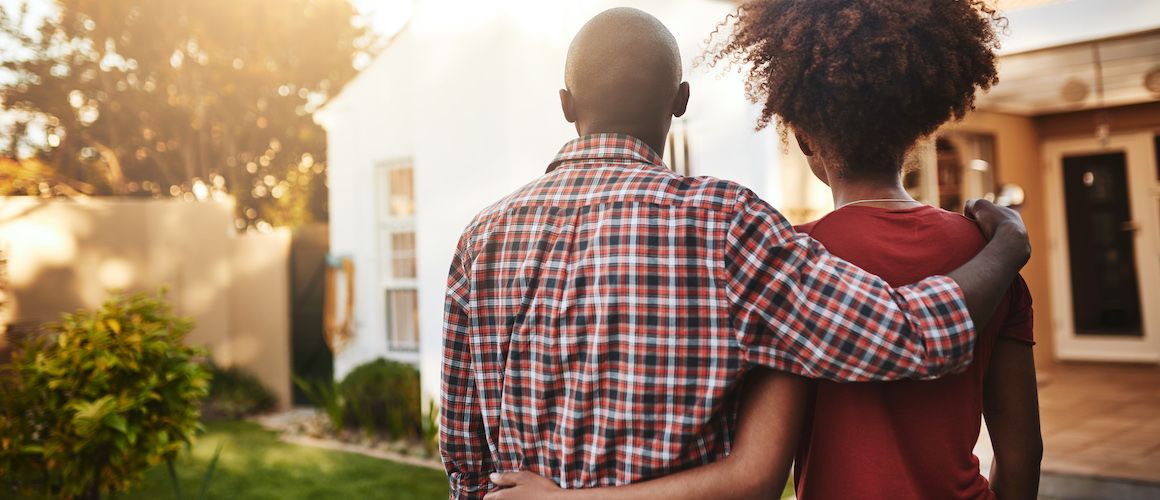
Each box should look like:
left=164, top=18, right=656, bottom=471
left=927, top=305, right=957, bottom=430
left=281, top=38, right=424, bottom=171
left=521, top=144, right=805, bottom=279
left=319, top=0, right=778, bottom=397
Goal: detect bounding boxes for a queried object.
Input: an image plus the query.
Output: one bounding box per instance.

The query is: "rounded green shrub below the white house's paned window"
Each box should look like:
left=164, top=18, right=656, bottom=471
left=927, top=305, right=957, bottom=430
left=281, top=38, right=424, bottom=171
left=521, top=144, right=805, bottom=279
left=340, top=360, right=423, bottom=439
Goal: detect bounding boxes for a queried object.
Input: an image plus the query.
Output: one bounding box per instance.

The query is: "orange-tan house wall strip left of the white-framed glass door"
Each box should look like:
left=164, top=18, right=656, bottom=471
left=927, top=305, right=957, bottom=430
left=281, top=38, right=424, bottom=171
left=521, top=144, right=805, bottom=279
left=944, top=111, right=1054, bottom=371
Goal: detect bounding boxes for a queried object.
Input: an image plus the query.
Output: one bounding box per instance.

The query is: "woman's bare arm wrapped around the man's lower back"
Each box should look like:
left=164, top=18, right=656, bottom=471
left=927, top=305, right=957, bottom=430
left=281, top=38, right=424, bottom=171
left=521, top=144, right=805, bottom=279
left=486, top=369, right=810, bottom=500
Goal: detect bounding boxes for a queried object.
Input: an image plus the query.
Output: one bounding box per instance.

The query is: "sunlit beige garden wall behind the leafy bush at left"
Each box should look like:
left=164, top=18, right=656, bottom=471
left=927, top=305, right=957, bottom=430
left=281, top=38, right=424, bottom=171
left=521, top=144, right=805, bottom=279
left=0, top=197, right=290, bottom=406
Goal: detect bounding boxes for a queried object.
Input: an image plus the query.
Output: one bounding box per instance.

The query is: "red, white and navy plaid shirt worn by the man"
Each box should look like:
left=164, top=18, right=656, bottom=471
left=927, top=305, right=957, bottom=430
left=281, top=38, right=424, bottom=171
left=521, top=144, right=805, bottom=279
left=440, top=135, right=974, bottom=498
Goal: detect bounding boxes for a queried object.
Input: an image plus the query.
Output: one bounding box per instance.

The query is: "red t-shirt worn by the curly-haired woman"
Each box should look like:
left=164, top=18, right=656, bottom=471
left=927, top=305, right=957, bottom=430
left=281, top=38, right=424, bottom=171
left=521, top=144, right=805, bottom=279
left=795, top=206, right=1034, bottom=500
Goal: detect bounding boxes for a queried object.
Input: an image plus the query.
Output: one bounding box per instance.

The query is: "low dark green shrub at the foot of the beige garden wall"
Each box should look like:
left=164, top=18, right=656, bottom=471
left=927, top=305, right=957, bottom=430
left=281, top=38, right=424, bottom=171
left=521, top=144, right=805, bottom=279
left=202, top=363, right=277, bottom=420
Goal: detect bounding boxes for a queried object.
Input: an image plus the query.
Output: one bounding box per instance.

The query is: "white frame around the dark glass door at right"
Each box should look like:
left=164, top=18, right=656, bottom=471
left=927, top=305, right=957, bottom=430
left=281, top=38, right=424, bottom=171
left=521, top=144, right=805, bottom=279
left=1043, top=131, right=1160, bottom=362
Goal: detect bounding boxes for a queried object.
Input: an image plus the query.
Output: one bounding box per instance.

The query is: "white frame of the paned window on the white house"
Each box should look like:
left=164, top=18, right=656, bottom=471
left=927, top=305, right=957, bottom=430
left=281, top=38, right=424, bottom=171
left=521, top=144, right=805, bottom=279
left=375, top=159, right=420, bottom=353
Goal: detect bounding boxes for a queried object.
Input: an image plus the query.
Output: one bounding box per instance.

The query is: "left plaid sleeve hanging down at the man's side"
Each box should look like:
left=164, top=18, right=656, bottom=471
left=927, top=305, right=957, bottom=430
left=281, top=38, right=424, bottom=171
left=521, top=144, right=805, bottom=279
left=438, top=237, right=494, bottom=499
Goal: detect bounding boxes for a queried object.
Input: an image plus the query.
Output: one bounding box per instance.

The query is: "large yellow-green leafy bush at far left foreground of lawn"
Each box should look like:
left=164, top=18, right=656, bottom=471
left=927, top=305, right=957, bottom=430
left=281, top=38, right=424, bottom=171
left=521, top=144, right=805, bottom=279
left=0, top=294, right=209, bottom=499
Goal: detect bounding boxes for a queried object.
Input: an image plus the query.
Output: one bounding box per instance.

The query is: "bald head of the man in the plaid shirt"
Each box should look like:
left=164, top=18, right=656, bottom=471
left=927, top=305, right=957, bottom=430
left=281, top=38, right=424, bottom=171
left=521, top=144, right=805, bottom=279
left=561, top=7, right=688, bottom=153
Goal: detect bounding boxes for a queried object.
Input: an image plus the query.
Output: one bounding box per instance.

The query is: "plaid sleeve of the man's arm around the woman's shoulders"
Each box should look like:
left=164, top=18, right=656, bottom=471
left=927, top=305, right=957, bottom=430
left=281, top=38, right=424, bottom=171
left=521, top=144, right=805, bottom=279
left=725, top=190, right=976, bottom=382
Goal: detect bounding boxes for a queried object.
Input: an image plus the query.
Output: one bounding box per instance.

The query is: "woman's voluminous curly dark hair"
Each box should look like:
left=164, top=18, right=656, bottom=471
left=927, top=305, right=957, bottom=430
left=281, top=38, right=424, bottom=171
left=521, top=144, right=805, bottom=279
left=708, top=0, right=1006, bottom=176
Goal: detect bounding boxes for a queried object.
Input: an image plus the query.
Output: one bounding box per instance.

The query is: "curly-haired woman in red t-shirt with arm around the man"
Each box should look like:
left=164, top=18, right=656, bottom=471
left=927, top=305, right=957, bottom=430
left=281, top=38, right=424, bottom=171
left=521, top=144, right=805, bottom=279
left=484, top=0, right=1043, bottom=499
